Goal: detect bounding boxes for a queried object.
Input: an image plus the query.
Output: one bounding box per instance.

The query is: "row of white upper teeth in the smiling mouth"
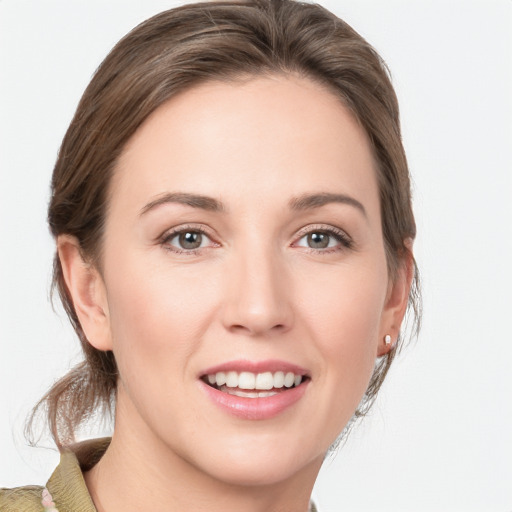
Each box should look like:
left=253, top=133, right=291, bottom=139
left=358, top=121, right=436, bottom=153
left=208, top=372, right=302, bottom=390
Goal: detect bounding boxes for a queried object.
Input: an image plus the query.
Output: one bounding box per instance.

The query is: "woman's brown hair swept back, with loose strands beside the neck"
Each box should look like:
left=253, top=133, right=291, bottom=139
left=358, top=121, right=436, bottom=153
left=32, top=0, right=419, bottom=446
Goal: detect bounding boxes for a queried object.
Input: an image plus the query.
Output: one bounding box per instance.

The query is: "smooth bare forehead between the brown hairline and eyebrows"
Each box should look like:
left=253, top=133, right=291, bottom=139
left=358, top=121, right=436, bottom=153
left=111, top=75, right=378, bottom=214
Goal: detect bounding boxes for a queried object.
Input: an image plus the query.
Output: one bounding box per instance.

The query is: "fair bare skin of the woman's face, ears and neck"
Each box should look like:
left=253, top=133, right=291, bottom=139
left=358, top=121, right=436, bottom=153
left=58, top=76, right=410, bottom=512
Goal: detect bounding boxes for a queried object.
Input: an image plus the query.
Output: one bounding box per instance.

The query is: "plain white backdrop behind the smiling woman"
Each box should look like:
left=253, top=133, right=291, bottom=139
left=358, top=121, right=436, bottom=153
left=0, top=0, right=512, bottom=512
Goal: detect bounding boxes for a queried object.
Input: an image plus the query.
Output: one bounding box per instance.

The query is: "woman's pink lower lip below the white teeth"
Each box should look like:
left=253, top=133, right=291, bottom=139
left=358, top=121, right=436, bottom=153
left=200, top=380, right=309, bottom=420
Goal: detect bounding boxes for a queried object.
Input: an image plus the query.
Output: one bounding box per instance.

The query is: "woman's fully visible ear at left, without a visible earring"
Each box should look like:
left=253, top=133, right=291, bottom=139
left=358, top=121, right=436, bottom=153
left=57, top=235, right=112, bottom=351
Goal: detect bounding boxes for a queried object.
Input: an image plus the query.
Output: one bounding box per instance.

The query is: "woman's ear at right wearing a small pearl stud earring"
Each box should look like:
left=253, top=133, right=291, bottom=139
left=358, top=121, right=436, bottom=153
left=377, top=240, right=414, bottom=357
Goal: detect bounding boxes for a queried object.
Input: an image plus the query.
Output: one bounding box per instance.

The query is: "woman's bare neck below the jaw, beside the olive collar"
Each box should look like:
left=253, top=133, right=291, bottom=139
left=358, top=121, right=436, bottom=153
left=84, top=400, right=322, bottom=512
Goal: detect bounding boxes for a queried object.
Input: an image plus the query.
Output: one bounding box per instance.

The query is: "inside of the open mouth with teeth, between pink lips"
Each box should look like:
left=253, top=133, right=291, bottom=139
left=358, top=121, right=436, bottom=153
left=201, top=370, right=309, bottom=398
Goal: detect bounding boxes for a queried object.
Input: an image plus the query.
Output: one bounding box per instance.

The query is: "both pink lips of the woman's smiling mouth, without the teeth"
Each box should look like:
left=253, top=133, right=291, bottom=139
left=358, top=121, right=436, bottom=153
left=199, top=360, right=310, bottom=420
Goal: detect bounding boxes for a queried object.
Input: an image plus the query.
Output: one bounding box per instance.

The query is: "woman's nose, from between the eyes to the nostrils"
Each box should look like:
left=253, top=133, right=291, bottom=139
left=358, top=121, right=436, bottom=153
left=222, top=243, right=293, bottom=336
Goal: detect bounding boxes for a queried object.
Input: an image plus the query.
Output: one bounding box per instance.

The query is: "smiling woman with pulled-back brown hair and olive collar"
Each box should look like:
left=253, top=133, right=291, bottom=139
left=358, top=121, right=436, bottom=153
left=0, top=0, right=417, bottom=512
